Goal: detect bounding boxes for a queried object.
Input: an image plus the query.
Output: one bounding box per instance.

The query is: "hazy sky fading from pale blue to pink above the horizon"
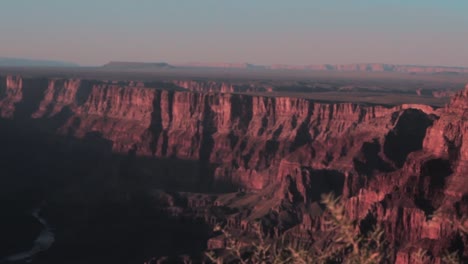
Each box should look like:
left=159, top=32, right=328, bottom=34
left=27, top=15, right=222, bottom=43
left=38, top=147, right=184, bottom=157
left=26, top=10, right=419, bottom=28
left=0, top=0, right=468, bottom=66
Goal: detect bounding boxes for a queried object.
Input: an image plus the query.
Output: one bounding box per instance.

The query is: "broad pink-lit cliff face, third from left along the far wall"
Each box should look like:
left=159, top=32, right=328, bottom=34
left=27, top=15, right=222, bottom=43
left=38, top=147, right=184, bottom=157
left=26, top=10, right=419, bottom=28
left=59, top=85, right=156, bottom=155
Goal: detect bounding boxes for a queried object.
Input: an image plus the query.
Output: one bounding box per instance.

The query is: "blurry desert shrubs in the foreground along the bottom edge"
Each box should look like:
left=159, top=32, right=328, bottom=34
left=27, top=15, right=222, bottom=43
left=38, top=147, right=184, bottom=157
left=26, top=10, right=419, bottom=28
left=206, top=193, right=468, bottom=264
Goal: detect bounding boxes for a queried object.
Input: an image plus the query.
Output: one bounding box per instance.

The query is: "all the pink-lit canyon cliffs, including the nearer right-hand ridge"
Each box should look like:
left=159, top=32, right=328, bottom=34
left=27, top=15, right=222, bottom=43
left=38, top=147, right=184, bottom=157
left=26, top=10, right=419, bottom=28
left=0, top=76, right=468, bottom=263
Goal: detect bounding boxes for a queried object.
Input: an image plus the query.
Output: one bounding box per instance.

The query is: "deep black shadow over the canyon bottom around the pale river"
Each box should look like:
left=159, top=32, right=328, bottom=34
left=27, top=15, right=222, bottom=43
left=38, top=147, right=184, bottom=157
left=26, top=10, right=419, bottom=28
left=0, top=120, right=216, bottom=263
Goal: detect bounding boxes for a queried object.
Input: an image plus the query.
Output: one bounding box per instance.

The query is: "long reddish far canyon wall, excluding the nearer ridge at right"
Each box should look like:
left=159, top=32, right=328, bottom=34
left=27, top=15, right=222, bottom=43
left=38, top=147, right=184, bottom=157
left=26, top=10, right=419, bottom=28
left=0, top=76, right=433, bottom=189
